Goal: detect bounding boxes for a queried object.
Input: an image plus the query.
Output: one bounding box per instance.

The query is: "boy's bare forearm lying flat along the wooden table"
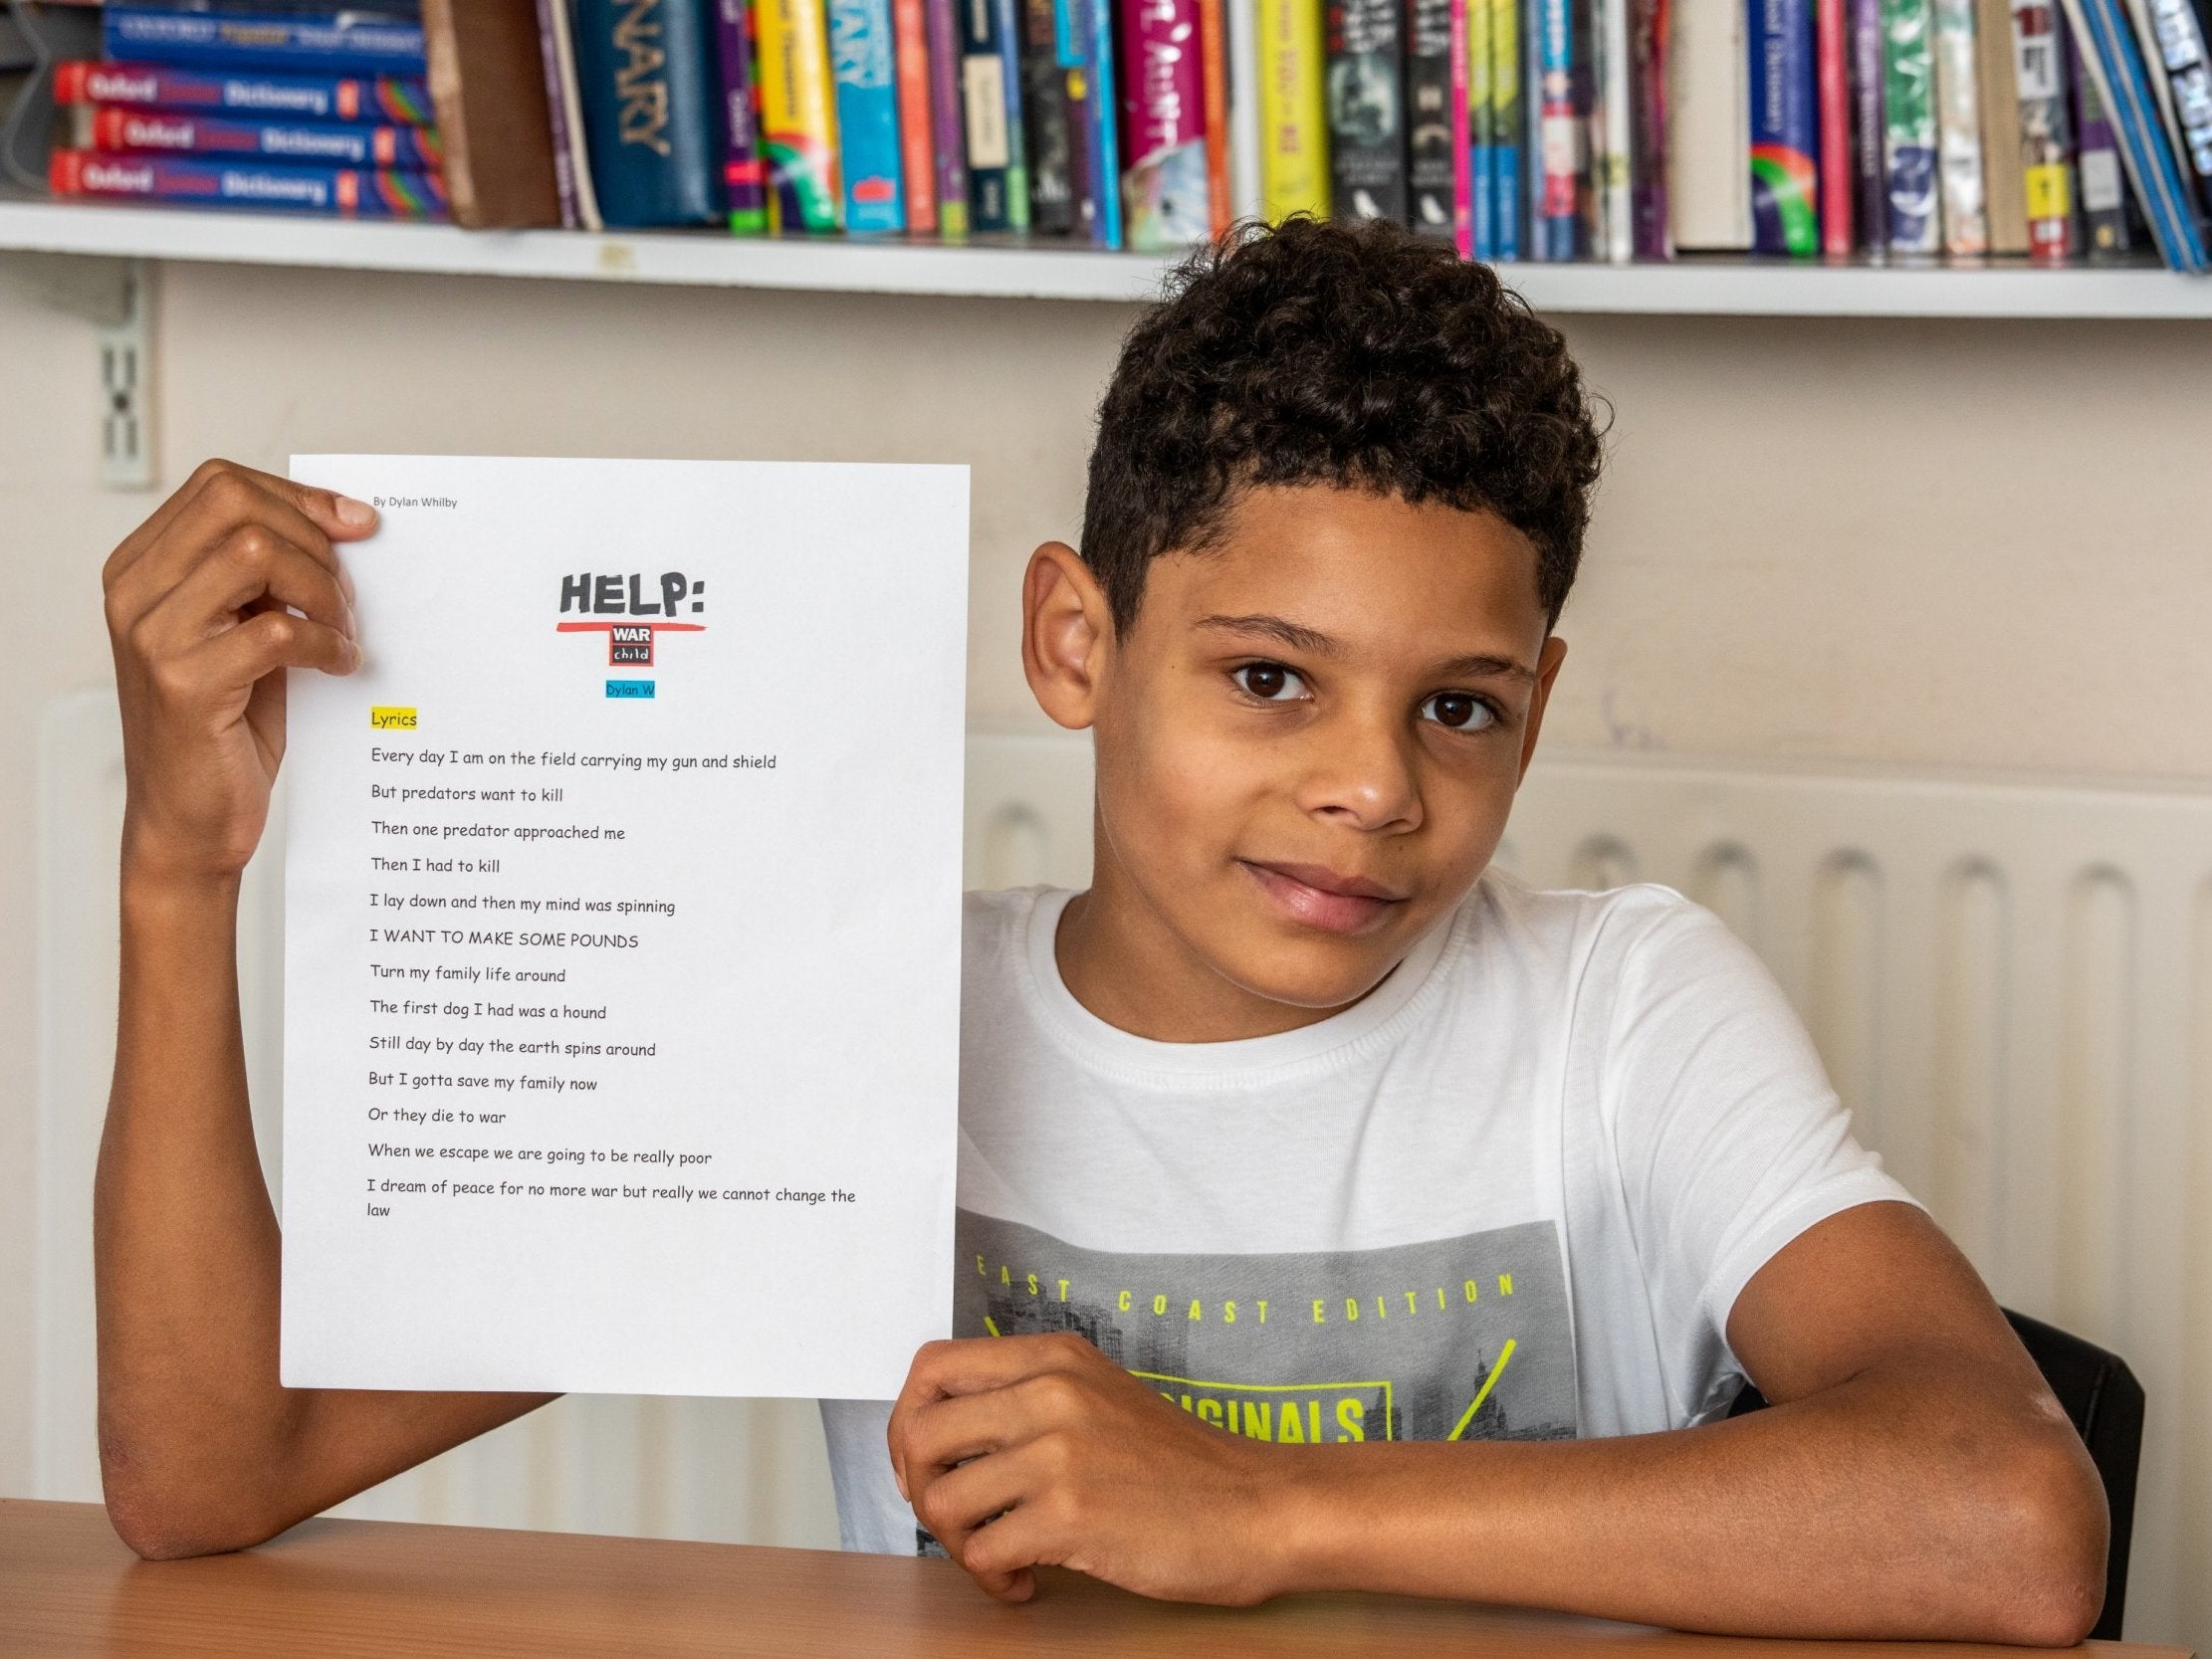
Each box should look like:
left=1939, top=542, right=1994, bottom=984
left=1261, top=1375, right=2103, bottom=1643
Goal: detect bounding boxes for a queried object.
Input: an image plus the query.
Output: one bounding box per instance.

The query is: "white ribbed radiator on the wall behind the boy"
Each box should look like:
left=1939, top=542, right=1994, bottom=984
left=33, top=695, right=2212, bottom=1646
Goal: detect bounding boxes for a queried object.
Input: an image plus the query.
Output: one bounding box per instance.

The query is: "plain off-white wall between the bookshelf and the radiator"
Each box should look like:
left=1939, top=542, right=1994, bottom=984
left=0, top=268, right=2212, bottom=1627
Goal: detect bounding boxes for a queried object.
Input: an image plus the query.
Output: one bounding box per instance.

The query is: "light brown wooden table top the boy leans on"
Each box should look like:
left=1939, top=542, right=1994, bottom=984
left=0, top=1500, right=2185, bottom=1659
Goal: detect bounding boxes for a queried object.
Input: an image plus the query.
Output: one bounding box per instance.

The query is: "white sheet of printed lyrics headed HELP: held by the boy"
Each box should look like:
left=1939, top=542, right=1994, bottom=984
left=281, top=456, right=967, bottom=1398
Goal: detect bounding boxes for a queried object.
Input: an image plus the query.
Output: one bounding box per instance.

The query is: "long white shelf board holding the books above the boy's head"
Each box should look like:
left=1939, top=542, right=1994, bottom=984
left=0, top=201, right=2212, bottom=318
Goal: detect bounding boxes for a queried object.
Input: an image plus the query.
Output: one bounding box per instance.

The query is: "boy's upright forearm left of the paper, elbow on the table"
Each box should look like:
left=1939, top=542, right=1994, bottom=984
left=93, top=858, right=290, bottom=1553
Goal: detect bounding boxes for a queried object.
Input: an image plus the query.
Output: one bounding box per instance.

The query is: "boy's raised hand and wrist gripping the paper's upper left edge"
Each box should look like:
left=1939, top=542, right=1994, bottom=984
left=102, top=460, right=376, bottom=881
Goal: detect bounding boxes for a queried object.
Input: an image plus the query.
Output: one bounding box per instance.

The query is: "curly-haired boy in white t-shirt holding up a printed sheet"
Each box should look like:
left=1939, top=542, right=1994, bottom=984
left=96, top=221, right=2105, bottom=1643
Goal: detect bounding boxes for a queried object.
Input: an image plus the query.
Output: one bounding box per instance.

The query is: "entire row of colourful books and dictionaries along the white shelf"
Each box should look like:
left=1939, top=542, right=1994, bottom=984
left=30, top=0, right=2212, bottom=270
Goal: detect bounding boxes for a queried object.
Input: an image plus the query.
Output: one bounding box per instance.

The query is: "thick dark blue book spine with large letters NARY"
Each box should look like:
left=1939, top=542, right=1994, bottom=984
left=575, top=0, right=726, bottom=230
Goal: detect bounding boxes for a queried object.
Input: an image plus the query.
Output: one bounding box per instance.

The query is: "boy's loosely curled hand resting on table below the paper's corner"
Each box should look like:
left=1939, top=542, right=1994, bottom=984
left=889, top=1334, right=1281, bottom=1606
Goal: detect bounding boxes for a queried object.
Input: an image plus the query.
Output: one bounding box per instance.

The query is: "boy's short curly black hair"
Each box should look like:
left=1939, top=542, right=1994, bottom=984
left=1082, top=217, right=1600, bottom=633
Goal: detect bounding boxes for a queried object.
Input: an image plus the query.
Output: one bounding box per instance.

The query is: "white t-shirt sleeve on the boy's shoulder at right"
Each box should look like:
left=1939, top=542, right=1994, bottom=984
left=1604, top=894, right=1915, bottom=1422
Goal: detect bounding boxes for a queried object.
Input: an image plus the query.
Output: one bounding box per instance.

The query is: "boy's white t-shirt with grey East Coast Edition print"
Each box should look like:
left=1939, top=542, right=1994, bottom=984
left=823, top=872, right=1911, bottom=1553
